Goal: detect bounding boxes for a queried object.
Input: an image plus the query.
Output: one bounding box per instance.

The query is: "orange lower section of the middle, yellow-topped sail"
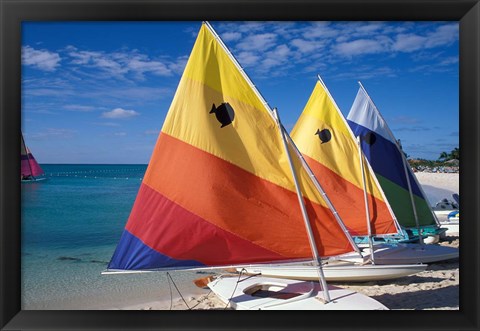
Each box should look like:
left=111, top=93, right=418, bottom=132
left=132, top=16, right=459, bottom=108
left=303, top=154, right=397, bottom=235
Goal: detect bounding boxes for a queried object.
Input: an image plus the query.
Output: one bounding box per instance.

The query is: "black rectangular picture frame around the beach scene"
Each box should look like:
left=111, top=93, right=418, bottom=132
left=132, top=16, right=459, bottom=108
left=0, top=0, right=480, bottom=330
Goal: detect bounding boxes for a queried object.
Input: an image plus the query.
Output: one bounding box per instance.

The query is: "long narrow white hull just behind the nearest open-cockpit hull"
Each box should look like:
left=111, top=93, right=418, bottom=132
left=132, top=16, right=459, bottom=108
left=240, top=263, right=427, bottom=282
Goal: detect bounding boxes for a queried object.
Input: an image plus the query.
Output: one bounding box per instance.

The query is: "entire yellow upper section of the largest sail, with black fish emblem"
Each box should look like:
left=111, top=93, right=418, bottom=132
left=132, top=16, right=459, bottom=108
left=162, top=25, right=324, bottom=205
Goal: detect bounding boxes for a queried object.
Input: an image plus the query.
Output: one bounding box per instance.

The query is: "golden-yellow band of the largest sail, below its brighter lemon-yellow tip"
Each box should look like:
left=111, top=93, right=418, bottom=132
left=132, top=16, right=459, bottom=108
left=162, top=74, right=295, bottom=195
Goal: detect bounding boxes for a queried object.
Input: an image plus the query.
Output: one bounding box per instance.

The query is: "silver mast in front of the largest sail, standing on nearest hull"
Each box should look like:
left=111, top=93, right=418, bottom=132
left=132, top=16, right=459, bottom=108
left=273, top=108, right=330, bottom=302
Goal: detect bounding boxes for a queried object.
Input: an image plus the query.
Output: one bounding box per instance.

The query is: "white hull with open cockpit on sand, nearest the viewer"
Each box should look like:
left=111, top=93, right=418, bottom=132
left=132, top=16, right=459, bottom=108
left=208, top=276, right=388, bottom=310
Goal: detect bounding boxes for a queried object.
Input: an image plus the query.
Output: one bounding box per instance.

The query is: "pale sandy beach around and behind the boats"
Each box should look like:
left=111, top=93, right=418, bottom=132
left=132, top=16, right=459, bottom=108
left=107, top=173, right=460, bottom=310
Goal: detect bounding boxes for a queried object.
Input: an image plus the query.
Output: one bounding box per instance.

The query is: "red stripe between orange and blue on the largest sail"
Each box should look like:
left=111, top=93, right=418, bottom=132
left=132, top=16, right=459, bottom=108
left=126, top=184, right=286, bottom=265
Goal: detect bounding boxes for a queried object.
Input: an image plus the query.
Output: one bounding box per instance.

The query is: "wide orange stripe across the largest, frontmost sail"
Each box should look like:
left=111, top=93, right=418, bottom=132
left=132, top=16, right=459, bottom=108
left=144, top=133, right=351, bottom=258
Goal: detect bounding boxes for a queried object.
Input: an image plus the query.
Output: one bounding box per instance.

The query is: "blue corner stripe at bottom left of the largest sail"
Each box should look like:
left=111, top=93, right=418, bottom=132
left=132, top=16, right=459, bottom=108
left=108, top=230, right=204, bottom=270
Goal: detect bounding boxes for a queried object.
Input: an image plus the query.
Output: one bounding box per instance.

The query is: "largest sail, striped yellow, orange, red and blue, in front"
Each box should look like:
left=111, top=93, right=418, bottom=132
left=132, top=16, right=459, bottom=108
left=108, top=24, right=352, bottom=270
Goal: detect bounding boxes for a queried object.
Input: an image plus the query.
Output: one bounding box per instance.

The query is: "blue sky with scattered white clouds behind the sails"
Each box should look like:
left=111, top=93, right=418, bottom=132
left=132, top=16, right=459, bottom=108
left=22, top=21, right=459, bottom=164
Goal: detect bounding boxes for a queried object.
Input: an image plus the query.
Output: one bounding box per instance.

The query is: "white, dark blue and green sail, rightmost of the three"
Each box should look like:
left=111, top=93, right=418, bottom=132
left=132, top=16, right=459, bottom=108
left=347, top=86, right=436, bottom=228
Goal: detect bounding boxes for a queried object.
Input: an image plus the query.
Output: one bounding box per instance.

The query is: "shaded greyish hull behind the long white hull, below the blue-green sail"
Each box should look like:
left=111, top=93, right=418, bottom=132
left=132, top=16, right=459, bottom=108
left=341, top=244, right=459, bottom=265
